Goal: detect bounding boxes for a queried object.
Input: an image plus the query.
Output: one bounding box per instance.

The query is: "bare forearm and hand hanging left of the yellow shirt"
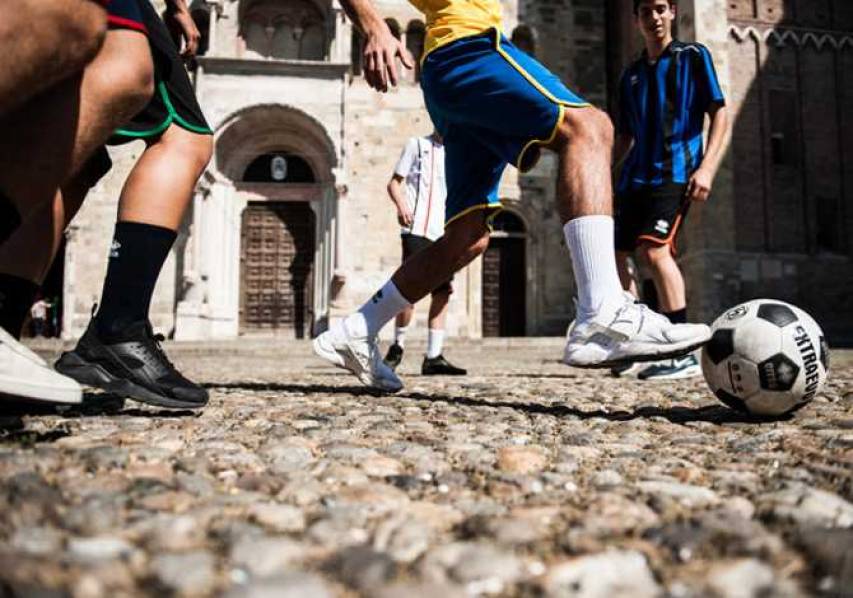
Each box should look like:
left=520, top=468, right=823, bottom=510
left=341, top=0, right=415, bottom=92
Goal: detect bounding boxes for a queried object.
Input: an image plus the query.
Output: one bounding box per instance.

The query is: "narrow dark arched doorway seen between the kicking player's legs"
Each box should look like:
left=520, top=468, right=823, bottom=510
left=483, top=210, right=527, bottom=336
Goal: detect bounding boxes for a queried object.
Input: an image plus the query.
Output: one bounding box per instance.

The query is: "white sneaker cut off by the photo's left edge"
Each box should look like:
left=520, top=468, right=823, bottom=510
left=0, top=328, right=83, bottom=405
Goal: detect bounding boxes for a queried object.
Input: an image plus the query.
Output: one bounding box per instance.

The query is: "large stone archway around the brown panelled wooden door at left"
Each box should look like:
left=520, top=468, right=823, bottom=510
left=175, top=105, right=338, bottom=339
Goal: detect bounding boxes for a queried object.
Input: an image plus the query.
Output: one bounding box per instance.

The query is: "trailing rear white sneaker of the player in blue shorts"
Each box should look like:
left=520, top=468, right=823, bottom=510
left=313, top=321, right=403, bottom=392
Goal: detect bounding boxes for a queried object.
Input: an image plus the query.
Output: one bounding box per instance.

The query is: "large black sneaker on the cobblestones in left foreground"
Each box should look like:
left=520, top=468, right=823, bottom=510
left=54, top=321, right=208, bottom=409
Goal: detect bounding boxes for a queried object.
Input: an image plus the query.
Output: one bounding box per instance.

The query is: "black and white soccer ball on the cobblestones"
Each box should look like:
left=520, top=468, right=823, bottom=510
left=702, top=299, right=829, bottom=416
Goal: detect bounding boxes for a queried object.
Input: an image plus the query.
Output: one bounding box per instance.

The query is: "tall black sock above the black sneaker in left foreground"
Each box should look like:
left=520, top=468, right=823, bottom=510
left=95, top=222, right=177, bottom=338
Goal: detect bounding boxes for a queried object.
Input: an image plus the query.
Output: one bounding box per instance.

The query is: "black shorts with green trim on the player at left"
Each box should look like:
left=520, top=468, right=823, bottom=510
left=110, top=0, right=213, bottom=145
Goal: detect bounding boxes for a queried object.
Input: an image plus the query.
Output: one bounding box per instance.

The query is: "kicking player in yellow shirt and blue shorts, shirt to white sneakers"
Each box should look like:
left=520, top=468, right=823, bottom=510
left=314, top=0, right=710, bottom=392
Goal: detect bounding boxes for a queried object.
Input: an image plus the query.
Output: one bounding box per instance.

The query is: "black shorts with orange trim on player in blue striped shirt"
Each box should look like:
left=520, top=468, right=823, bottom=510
left=614, top=183, right=690, bottom=254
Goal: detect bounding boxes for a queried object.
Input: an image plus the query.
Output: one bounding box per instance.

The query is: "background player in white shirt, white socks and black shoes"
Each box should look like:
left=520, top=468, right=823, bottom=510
left=385, top=132, right=467, bottom=376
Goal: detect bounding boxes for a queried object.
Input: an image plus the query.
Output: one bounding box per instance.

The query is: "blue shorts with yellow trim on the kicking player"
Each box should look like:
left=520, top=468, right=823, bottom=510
left=421, top=29, right=589, bottom=229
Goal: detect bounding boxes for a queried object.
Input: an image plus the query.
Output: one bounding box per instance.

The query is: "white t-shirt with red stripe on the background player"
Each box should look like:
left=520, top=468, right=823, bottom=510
left=394, top=137, right=447, bottom=241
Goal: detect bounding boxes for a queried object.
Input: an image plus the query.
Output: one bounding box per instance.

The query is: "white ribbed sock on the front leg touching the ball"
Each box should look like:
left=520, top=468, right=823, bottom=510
left=563, top=216, right=622, bottom=322
